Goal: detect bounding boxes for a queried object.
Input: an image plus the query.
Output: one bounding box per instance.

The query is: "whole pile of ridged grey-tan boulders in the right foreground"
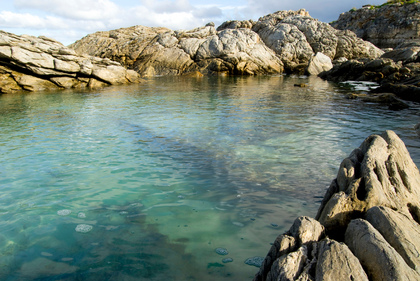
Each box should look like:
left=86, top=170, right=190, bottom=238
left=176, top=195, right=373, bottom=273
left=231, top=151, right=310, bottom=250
left=254, top=131, right=420, bottom=280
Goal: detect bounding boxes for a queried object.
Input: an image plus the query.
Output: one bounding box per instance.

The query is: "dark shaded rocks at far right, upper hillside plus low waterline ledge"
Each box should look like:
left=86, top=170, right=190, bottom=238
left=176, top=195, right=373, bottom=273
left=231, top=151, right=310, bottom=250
left=320, top=2, right=420, bottom=102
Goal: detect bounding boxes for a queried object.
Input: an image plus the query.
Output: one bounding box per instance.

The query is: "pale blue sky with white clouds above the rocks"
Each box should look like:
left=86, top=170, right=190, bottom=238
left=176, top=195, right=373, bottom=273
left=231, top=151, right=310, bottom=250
left=0, top=0, right=386, bottom=45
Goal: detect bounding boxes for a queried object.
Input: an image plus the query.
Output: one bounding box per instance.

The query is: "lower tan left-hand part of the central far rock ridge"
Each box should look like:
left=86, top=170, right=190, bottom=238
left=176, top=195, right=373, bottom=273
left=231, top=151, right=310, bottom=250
left=71, top=24, right=283, bottom=76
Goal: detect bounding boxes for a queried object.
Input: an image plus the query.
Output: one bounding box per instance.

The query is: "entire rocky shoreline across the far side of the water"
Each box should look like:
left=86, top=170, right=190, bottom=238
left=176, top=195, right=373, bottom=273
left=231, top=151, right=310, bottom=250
left=0, top=2, right=420, bottom=102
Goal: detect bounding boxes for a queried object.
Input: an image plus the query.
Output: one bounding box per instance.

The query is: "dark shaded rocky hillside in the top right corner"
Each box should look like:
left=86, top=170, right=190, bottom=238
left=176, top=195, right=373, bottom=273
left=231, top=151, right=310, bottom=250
left=331, top=2, right=420, bottom=48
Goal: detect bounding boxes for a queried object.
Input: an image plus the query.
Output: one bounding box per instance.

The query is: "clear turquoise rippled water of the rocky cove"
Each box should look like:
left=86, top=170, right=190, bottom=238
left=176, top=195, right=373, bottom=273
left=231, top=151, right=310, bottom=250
left=0, top=76, right=420, bottom=280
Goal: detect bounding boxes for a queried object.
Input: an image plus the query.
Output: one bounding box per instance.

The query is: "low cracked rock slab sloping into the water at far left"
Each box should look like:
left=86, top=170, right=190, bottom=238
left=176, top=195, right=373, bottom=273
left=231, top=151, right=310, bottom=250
left=0, top=31, right=140, bottom=93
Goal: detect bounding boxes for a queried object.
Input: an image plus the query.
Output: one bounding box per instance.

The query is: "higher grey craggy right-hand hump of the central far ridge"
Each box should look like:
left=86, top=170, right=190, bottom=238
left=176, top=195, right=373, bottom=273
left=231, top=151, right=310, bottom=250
left=252, top=9, right=383, bottom=72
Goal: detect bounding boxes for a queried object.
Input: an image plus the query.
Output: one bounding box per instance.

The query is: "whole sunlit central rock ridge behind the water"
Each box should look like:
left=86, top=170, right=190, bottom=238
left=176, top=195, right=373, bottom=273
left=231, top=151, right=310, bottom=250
left=71, top=9, right=383, bottom=76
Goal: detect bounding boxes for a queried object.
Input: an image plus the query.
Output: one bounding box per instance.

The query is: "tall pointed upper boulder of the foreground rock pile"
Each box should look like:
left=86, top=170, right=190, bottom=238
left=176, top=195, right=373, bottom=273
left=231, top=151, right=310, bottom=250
left=316, top=131, right=420, bottom=236
